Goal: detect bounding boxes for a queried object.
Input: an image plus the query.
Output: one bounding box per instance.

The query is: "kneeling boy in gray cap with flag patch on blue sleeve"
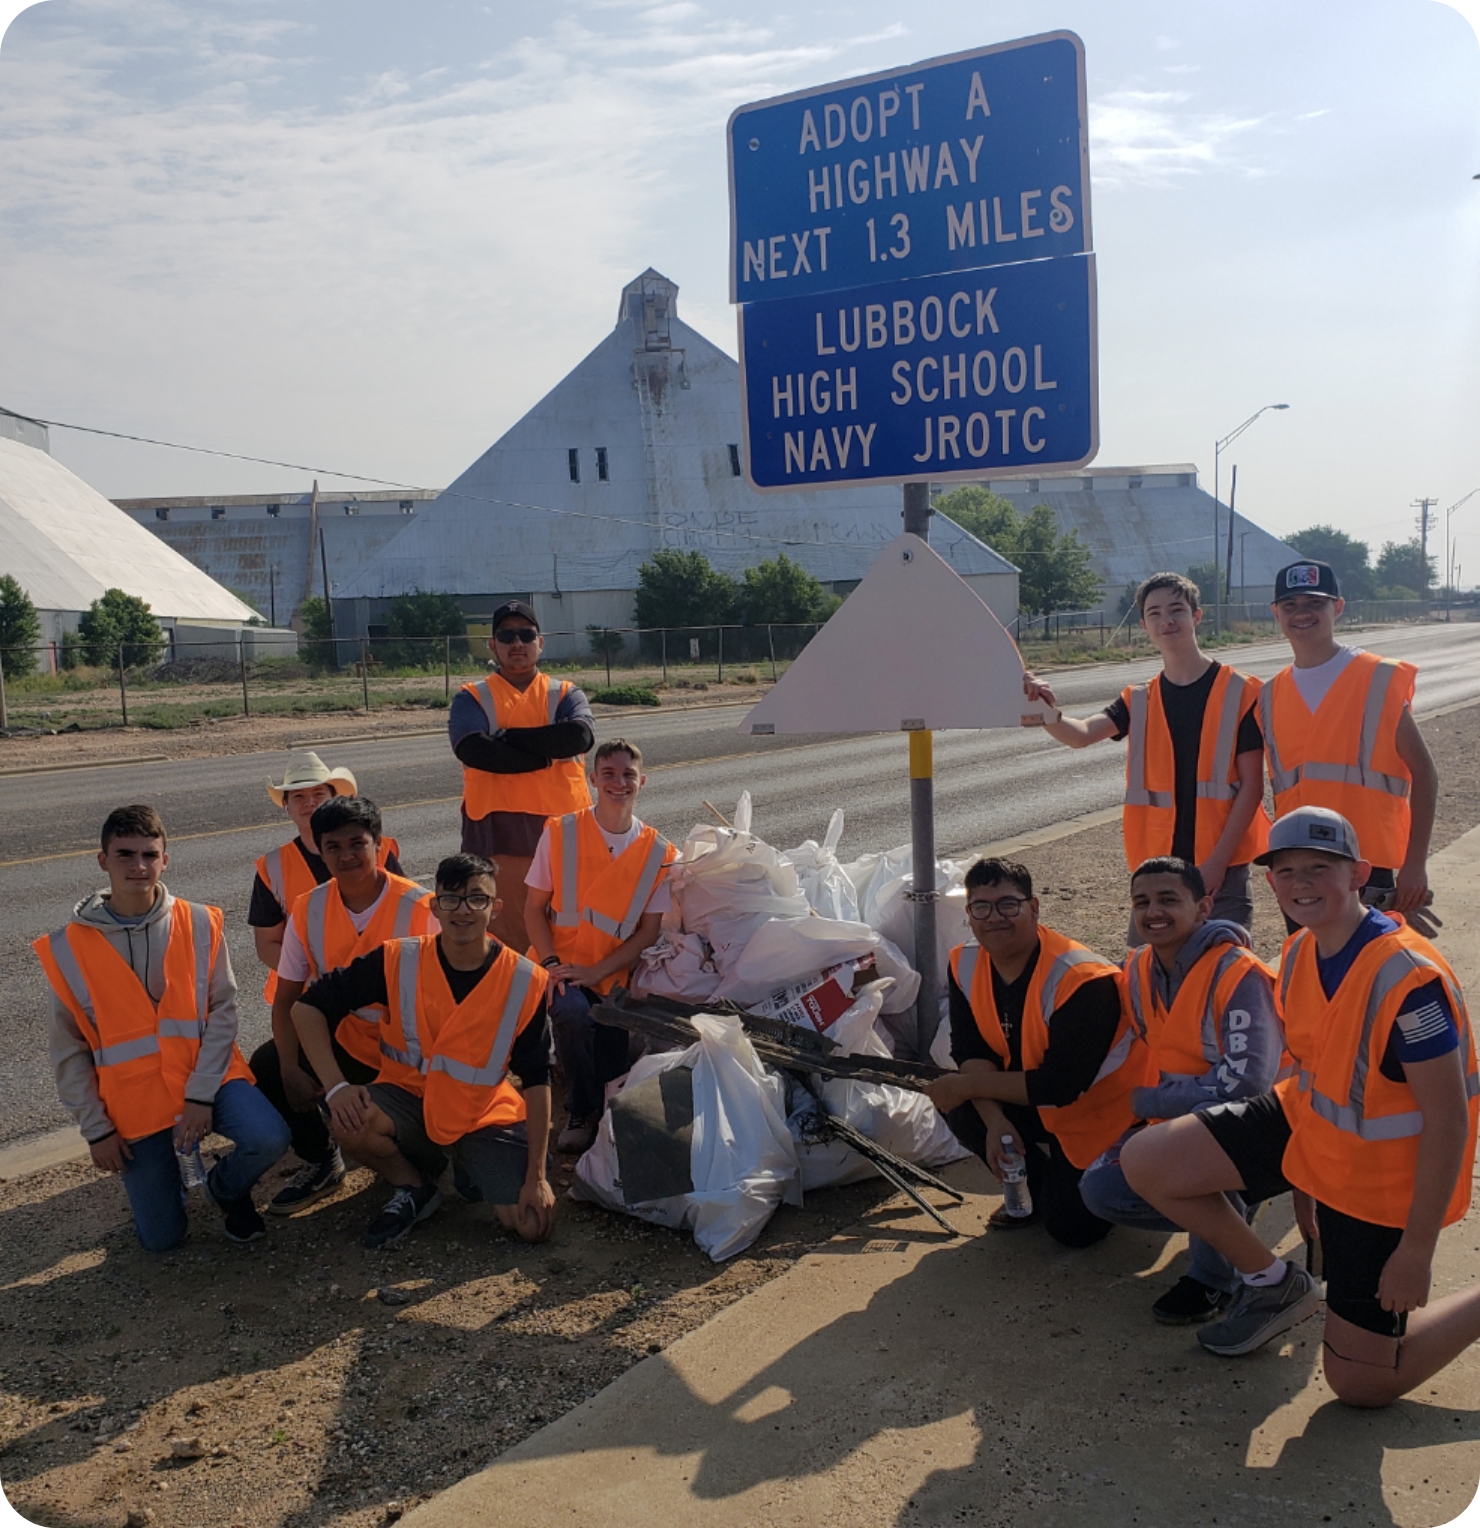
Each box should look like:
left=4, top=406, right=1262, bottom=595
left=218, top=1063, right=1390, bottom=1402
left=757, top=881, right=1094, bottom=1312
left=1121, top=807, right=1480, bottom=1406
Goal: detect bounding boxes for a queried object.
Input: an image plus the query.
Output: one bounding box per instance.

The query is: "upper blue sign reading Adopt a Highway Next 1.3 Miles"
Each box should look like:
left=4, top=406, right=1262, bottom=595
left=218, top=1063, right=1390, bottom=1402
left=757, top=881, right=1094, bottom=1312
left=729, top=32, right=1092, bottom=303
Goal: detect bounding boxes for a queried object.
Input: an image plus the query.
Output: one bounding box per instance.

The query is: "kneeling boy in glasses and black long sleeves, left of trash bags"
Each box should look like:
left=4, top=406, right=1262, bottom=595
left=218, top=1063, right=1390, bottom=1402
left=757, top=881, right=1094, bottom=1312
left=293, top=854, right=554, bottom=1247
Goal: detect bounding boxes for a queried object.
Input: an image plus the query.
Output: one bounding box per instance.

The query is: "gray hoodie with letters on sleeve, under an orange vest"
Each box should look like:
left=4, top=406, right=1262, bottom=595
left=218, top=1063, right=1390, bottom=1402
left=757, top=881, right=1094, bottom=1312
left=1130, top=918, right=1284, bottom=1120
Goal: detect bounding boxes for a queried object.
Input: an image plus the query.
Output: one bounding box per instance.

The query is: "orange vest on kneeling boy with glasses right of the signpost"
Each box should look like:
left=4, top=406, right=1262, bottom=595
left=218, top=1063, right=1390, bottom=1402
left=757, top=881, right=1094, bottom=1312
left=950, top=927, right=1150, bottom=1167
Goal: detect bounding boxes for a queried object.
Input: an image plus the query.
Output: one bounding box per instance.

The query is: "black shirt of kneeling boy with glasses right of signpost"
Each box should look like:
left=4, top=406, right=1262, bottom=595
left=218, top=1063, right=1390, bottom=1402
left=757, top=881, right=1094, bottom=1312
left=950, top=946, right=1121, bottom=1123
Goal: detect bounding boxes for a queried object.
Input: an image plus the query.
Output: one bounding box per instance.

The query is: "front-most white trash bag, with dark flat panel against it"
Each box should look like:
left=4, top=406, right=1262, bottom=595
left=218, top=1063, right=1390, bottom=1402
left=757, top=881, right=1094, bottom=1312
left=570, top=1013, right=802, bottom=1262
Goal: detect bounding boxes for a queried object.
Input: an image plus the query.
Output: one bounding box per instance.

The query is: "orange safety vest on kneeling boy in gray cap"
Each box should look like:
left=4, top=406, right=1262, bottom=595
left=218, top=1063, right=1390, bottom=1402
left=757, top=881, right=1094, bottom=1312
left=1275, top=923, right=1480, bottom=1229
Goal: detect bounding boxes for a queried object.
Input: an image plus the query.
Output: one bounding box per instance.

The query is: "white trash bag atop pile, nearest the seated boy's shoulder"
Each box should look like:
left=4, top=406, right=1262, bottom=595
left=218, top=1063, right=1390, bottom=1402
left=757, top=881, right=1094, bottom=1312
left=669, top=790, right=811, bottom=975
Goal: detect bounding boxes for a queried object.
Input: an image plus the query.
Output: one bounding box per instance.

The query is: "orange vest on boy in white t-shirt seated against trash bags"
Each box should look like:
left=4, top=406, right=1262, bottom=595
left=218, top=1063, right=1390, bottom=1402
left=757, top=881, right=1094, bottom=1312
left=532, top=807, right=678, bottom=992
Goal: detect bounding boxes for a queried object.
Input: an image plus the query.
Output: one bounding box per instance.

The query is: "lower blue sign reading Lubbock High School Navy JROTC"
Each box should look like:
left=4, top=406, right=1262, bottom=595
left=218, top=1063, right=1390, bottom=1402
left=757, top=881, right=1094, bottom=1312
left=741, top=255, right=1098, bottom=492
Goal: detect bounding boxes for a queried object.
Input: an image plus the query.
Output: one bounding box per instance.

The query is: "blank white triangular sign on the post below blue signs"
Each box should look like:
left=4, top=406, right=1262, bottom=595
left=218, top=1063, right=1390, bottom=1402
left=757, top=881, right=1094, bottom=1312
left=739, top=533, right=1049, bottom=733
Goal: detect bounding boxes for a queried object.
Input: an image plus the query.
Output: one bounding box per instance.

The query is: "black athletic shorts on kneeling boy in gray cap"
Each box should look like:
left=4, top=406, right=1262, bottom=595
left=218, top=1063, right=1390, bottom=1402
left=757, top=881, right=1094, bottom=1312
left=1196, top=1093, right=1408, bottom=1337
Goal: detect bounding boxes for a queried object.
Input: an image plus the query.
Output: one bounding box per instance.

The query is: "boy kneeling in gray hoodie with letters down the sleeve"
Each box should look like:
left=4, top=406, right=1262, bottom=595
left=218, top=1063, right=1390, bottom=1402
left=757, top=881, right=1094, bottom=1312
left=1080, top=856, right=1284, bottom=1326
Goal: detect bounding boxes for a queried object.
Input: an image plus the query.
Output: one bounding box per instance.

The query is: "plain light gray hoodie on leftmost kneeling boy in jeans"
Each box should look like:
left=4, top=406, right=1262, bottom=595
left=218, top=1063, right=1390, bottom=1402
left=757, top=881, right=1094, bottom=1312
left=46, top=885, right=237, bottom=1141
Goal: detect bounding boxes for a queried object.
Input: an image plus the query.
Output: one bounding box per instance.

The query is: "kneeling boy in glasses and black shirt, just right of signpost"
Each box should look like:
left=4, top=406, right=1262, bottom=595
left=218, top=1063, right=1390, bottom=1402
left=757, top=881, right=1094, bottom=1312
left=926, top=859, right=1147, bottom=1247
